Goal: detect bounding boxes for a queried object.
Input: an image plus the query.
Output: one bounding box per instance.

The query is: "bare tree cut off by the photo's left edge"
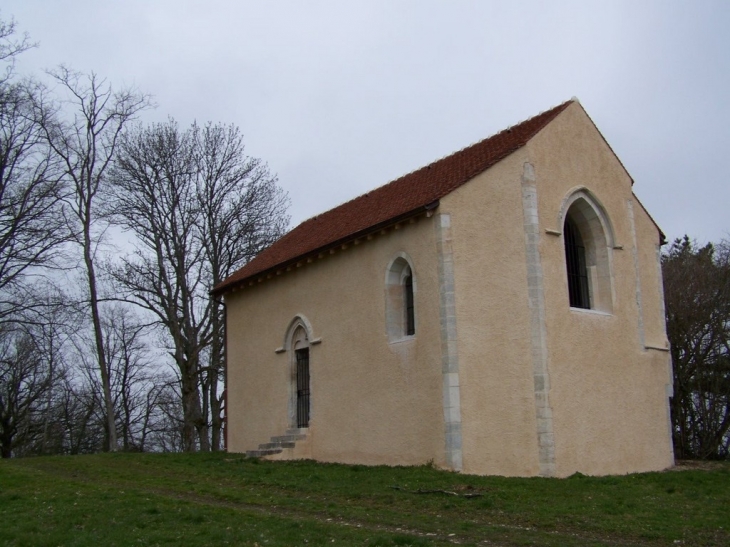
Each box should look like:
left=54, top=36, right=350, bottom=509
left=0, top=20, right=68, bottom=457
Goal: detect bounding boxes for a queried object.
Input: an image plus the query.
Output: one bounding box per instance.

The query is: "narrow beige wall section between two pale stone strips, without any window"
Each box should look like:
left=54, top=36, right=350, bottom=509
left=439, top=151, right=539, bottom=475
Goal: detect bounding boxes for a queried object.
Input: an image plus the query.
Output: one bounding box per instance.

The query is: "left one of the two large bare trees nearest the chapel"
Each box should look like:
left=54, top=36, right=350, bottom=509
left=112, top=122, right=209, bottom=451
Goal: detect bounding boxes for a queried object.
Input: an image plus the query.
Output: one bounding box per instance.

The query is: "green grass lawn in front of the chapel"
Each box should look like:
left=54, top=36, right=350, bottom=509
left=0, top=454, right=730, bottom=547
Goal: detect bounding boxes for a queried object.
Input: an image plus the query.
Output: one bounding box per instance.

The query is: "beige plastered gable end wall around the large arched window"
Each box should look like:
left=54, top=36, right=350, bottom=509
left=440, top=103, right=673, bottom=476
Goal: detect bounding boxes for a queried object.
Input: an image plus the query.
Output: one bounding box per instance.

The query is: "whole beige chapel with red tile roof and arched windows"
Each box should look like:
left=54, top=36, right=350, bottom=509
left=214, top=99, right=674, bottom=477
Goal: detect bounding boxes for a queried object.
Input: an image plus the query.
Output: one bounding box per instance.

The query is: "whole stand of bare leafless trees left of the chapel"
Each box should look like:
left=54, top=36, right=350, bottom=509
left=0, top=13, right=288, bottom=454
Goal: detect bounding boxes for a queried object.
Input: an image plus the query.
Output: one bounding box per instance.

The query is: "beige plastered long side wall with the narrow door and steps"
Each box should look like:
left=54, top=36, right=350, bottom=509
left=226, top=216, right=444, bottom=465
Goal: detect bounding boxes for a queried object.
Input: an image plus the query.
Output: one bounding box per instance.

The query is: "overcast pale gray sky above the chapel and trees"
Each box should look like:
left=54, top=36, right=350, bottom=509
left=5, top=0, right=730, bottom=241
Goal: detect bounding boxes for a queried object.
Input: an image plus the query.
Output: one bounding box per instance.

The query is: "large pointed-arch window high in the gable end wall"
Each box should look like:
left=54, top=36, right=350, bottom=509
left=563, top=189, right=613, bottom=313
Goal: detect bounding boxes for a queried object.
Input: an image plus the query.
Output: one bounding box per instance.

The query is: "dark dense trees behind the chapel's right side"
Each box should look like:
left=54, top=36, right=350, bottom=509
left=662, top=236, right=730, bottom=459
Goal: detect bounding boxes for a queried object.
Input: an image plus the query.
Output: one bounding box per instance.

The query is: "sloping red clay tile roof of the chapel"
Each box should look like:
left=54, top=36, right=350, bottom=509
left=213, top=100, right=573, bottom=295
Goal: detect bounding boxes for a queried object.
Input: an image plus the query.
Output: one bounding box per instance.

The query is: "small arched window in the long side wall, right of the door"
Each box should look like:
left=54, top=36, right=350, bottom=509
left=385, top=254, right=416, bottom=342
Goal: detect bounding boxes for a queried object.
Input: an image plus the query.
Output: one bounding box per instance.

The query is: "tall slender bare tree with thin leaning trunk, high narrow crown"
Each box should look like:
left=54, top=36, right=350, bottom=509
left=37, top=67, right=150, bottom=450
